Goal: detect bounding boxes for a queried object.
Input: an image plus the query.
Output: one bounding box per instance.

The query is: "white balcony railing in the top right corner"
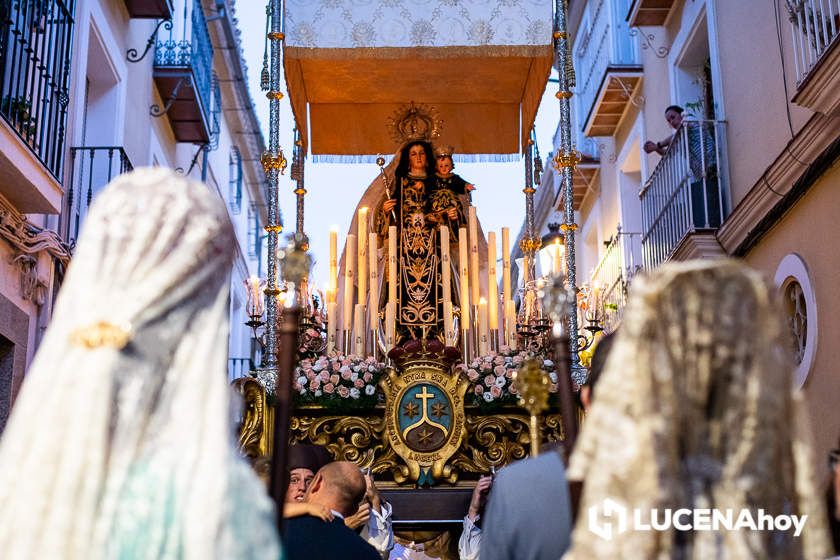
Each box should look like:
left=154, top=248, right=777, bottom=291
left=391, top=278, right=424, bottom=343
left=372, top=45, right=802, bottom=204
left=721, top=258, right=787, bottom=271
left=785, top=0, right=840, bottom=83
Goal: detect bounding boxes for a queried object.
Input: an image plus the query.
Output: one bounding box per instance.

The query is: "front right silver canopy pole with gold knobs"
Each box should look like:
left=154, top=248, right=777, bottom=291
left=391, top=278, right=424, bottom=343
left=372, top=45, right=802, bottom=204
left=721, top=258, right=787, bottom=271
left=554, top=0, right=587, bottom=385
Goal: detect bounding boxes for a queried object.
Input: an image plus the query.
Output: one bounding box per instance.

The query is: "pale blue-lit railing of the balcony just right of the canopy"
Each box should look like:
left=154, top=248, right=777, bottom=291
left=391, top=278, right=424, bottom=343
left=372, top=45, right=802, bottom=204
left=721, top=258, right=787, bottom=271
left=574, top=0, right=641, bottom=126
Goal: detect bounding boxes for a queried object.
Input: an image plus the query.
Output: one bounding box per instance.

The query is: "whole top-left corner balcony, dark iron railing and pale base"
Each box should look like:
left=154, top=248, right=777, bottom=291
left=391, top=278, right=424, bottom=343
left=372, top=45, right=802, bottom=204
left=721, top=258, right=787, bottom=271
left=0, top=0, right=74, bottom=214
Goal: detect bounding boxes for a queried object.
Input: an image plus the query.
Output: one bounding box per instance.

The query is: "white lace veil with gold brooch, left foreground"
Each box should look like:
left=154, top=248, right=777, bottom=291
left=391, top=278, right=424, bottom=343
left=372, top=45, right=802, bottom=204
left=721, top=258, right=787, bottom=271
left=0, top=169, right=280, bottom=559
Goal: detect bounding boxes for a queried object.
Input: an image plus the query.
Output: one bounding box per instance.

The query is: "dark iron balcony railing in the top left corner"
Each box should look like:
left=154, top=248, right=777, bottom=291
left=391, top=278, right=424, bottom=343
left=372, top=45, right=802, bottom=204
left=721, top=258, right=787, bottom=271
left=0, top=0, right=75, bottom=181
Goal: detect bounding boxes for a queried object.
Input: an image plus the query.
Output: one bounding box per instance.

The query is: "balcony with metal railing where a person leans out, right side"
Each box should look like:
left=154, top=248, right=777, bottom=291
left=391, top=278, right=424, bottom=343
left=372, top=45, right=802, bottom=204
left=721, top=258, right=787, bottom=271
left=639, top=120, right=726, bottom=269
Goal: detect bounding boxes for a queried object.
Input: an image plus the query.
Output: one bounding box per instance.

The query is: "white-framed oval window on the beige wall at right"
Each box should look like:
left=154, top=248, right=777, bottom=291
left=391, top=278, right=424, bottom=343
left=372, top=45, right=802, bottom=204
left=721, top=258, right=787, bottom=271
left=775, top=253, right=817, bottom=387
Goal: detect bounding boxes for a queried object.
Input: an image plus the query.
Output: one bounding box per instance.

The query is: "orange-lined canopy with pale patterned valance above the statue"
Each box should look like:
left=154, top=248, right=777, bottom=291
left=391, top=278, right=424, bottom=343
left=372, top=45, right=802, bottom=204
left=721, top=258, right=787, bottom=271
left=284, top=0, right=553, bottom=159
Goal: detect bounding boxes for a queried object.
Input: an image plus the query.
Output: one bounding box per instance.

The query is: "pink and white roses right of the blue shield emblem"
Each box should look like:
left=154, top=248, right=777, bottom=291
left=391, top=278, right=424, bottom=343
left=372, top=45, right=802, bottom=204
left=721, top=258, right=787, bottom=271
left=457, top=346, right=557, bottom=408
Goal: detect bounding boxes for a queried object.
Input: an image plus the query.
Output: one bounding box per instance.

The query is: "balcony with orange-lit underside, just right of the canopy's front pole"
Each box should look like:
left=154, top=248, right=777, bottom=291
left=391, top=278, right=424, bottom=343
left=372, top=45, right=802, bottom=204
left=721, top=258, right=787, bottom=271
left=574, top=0, right=642, bottom=136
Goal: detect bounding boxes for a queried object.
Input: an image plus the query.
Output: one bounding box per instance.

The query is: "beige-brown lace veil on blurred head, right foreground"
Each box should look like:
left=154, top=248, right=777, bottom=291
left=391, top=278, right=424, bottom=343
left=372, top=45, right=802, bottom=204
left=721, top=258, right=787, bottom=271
left=565, top=261, right=828, bottom=559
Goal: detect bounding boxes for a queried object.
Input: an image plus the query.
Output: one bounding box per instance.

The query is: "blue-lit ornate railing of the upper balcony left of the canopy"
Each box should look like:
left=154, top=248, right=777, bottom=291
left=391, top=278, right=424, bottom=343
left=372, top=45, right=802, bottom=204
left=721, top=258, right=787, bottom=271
left=155, top=0, right=213, bottom=121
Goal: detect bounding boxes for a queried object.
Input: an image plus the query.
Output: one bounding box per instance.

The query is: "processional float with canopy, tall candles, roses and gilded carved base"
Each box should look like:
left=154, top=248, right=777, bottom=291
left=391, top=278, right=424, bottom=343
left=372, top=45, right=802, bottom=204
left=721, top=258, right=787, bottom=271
left=236, top=0, right=585, bottom=529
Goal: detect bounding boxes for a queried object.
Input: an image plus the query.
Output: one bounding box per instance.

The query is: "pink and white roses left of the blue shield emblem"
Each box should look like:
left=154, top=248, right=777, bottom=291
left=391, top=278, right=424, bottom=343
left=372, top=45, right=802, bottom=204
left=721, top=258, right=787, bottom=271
left=292, top=354, right=385, bottom=408
